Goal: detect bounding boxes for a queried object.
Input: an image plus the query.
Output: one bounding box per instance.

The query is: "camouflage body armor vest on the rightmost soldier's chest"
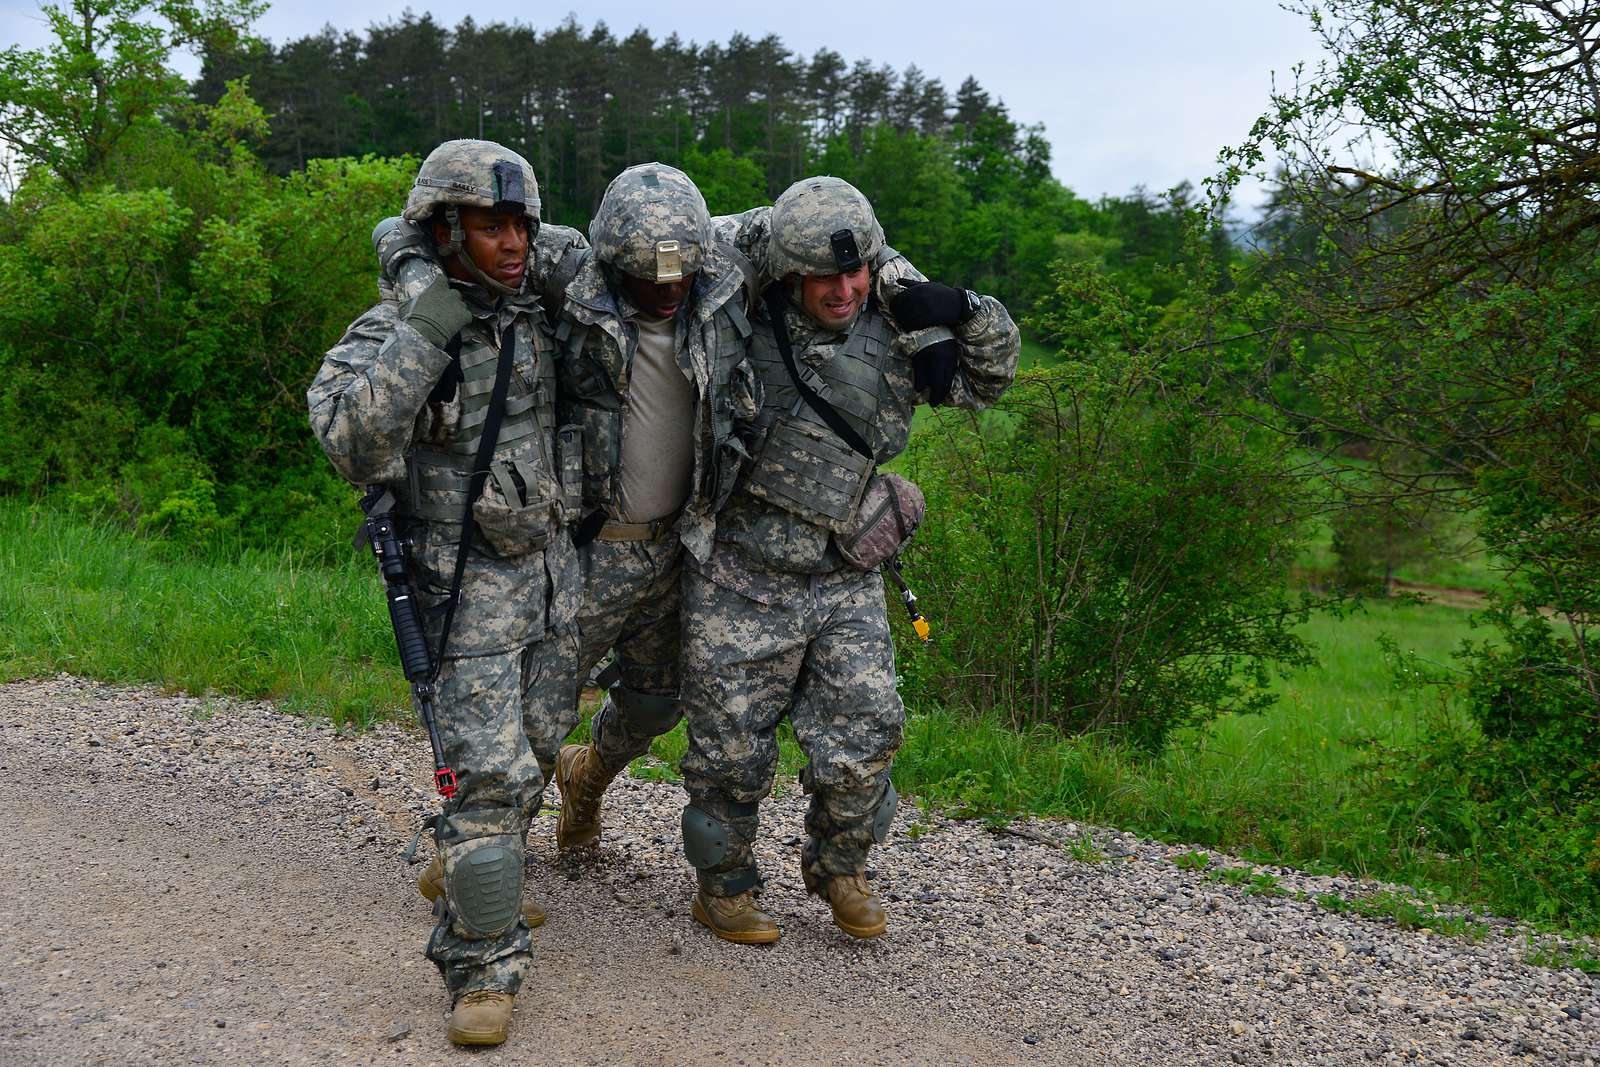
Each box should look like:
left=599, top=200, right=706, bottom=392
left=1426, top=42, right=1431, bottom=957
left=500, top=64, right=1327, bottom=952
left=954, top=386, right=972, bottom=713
left=744, top=307, right=894, bottom=533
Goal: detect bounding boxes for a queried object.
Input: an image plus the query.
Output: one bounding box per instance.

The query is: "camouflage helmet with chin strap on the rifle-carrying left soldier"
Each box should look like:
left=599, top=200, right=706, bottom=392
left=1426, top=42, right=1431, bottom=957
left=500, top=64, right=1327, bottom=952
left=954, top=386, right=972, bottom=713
left=405, top=139, right=539, bottom=293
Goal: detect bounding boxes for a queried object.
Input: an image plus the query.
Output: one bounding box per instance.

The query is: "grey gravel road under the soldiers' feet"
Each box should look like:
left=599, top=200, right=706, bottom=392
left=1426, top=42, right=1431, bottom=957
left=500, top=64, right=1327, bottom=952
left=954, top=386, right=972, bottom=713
left=0, top=677, right=1600, bottom=1067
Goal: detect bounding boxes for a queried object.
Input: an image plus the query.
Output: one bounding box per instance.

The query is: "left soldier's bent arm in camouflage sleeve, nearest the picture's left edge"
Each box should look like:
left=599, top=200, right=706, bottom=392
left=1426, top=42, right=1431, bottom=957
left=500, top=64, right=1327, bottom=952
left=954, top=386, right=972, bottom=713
left=306, top=302, right=450, bottom=485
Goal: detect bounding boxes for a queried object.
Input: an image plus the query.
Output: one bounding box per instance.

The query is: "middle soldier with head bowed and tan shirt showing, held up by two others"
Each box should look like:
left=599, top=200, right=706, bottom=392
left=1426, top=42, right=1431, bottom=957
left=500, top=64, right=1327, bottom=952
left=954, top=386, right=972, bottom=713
left=379, top=171, right=949, bottom=863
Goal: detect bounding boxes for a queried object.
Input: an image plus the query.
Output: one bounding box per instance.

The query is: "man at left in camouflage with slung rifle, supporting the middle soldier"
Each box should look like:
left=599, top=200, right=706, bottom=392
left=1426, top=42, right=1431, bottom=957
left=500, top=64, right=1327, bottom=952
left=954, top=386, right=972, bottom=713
left=307, top=141, right=581, bottom=1045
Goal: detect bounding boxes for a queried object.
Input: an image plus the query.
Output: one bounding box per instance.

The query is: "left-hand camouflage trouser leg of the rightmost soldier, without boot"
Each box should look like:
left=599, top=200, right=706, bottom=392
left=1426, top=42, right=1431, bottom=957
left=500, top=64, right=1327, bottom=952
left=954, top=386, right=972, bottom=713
left=682, top=571, right=806, bottom=929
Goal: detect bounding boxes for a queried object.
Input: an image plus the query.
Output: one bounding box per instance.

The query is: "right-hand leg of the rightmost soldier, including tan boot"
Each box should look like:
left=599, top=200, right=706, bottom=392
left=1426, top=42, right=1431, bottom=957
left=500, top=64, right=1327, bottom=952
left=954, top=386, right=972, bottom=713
left=790, top=573, right=906, bottom=936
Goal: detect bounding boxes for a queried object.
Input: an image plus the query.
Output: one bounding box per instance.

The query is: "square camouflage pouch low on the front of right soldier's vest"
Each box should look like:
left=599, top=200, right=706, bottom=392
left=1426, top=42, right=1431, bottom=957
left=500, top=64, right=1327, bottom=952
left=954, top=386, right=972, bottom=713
left=744, top=416, right=874, bottom=533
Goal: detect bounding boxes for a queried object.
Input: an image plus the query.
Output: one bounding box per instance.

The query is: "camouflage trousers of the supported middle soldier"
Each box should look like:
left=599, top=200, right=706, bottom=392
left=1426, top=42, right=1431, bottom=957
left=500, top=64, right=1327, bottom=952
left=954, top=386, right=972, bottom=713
left=530, top=534, right=683, bottom=773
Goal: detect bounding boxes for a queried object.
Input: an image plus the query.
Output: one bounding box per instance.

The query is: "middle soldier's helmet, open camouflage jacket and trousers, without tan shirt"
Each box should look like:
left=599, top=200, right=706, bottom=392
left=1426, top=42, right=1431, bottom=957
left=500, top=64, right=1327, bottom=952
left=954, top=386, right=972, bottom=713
left=536, top=163, right=757, bottom=774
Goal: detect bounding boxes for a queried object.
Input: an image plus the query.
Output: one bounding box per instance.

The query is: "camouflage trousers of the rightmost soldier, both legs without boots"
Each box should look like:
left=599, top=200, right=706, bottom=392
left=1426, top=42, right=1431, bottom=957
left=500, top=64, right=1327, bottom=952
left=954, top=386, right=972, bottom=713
left=682, top=563, right=906, bottom=896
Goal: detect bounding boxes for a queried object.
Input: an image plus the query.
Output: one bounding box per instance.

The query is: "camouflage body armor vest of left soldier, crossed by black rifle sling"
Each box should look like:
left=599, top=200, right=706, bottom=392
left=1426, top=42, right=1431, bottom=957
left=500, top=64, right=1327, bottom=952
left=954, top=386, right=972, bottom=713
left=402, top=310, right=562, bottom=549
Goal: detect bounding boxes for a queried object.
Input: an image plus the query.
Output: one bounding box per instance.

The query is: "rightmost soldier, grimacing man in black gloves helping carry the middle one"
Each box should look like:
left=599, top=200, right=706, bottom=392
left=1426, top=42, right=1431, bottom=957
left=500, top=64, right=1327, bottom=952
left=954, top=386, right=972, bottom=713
left=683, top=178, right=1019, bottom=944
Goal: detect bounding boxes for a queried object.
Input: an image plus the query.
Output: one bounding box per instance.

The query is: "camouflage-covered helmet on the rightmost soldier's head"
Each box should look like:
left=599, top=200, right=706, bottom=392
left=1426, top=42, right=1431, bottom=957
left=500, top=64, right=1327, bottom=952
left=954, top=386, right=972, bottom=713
left=766, top=176, right=883, bottom=278
